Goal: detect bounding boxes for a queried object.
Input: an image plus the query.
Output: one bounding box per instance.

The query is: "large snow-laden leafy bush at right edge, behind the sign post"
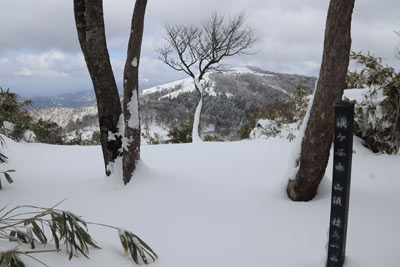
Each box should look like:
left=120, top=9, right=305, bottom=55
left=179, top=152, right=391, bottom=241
left=345, top=52, right=400, bottom=154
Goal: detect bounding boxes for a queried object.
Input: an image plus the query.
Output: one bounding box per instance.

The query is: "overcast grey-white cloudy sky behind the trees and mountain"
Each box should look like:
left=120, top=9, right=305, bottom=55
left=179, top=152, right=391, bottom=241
left=0, top=0, right=400, bottom=96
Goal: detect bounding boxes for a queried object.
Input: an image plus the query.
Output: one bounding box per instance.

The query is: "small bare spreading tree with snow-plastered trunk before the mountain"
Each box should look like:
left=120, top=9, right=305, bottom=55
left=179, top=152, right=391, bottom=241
left=157, top=12, right=256, bottom=142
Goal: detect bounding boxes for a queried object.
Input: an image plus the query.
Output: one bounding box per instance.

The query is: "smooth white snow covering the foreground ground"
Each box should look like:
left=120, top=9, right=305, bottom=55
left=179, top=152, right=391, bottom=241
left=0, top=138, right=400, bottom=267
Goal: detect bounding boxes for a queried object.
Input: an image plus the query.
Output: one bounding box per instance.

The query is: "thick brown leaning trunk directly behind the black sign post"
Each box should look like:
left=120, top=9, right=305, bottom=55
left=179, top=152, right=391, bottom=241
left=287, top=0, right=355, bottom=201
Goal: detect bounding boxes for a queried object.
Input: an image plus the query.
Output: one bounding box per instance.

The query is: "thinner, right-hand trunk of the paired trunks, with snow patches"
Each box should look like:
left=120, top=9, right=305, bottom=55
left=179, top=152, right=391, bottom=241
left=123, top=0, right=147, bottom=184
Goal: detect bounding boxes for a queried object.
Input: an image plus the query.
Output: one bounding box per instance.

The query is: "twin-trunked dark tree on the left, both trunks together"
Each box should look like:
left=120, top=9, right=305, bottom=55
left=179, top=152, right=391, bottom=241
left=74, top=0, right=147, bottom=184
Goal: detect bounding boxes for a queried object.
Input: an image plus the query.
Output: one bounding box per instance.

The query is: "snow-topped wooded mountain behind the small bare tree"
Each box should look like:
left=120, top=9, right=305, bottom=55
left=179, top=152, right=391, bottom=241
left=140, top=67, right=316, bottom=139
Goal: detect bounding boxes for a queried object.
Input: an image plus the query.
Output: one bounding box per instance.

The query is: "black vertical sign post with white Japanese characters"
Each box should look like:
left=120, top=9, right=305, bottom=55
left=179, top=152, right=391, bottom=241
left=327, top=101, right=354, bottom=267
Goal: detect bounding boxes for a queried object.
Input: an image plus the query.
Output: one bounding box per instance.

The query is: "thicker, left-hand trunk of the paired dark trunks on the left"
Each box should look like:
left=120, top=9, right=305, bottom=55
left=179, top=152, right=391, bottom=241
left=74, top=0, right=122, bottom=175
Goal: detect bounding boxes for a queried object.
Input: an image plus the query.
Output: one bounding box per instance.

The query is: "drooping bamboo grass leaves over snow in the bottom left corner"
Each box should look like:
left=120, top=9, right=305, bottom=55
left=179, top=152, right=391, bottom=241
left=0, top=205, right=157, bottom=266
